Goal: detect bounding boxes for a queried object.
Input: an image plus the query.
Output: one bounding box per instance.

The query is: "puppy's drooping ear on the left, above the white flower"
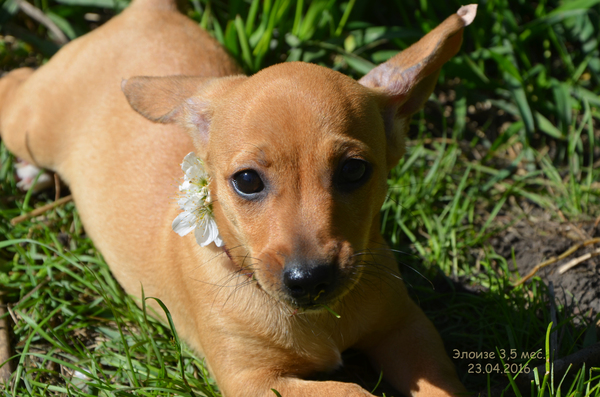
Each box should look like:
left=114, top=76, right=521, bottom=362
left=121, top=76, right=247, bottom=152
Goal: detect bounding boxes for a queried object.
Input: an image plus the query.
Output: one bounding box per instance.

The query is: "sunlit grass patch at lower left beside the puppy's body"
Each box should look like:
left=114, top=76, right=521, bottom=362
left=0, top=148, right=217, bottom=396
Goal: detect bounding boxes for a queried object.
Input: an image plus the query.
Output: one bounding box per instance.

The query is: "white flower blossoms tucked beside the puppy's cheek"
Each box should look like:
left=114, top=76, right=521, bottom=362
left=172, top=152, right=223, bottom=247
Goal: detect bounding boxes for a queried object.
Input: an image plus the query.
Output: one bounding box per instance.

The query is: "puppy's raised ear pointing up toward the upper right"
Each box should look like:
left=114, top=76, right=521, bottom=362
left=359, top=4, right=477, bottom=168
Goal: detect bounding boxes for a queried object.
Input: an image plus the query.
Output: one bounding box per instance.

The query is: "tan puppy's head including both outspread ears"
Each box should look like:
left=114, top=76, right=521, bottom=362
left=123, top=6, right=475, bottom=310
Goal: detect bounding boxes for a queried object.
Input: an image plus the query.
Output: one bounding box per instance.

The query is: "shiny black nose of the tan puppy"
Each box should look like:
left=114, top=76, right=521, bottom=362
left=283, top=262, right=335, bottom=306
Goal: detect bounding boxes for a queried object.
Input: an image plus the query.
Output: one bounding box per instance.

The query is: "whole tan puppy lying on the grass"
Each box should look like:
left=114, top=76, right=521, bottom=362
left=0, top=0, right=476, bottom=397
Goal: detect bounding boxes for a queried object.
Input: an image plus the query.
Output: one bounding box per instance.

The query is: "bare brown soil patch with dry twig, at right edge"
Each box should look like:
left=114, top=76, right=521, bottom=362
left=491, top=209, right=600, bottom=319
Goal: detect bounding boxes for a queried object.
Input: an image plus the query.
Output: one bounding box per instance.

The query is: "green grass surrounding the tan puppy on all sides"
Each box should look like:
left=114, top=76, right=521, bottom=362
left=0, top=0, right=600, bottom=397
